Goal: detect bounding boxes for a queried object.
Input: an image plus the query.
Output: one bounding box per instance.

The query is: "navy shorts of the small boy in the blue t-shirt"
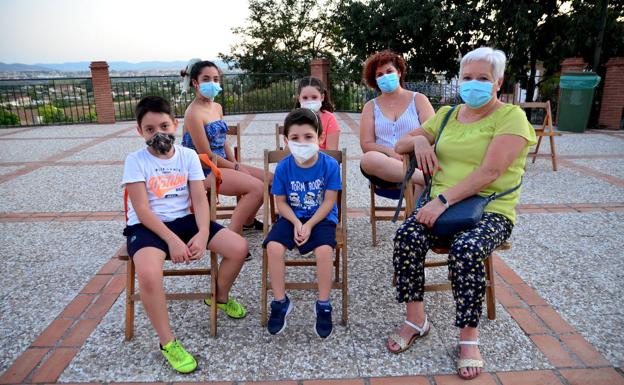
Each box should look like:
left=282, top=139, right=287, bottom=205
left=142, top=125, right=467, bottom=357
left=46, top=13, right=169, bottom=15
left=262, top=217, right=336, bottom=254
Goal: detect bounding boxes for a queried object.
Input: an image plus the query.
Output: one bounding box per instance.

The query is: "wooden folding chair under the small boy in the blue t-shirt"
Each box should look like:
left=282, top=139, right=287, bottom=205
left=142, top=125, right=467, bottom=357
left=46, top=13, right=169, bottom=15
left=260, top=149, right=349, bottom=326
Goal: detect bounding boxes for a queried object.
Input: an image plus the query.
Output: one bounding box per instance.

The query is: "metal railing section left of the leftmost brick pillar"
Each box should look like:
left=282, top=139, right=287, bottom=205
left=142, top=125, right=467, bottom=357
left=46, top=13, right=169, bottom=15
left=0, top=78, right=97, bottom=127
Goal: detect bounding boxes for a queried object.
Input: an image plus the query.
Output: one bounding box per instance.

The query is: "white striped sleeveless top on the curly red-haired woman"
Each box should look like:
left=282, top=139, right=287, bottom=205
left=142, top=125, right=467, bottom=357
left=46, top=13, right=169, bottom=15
left=373, top=92, right=420, bottom=148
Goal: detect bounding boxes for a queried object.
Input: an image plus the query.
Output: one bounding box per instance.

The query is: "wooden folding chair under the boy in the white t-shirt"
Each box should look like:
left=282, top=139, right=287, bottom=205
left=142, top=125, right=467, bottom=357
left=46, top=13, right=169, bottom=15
left=117, top=164, right=219, bottom=341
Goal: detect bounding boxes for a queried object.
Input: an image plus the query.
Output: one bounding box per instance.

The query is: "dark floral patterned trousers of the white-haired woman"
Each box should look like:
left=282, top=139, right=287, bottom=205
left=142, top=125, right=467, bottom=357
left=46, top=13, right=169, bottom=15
left=393, top=208, right=513, bottom=328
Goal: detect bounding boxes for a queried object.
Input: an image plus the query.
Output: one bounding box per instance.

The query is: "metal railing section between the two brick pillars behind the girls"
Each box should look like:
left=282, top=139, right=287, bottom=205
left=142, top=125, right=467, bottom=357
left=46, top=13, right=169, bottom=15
left=111, top=73, right=303, bottom=120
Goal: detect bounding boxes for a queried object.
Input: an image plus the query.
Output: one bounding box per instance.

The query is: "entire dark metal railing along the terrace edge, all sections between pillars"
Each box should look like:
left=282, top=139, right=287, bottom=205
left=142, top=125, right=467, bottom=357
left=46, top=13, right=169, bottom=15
left=0, top=73, right=559, bottom=127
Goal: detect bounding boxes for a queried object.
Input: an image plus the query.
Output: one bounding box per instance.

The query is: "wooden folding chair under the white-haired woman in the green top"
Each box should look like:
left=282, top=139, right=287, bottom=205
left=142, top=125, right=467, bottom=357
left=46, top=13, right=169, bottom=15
left=392, top=153, right=511, bottom=320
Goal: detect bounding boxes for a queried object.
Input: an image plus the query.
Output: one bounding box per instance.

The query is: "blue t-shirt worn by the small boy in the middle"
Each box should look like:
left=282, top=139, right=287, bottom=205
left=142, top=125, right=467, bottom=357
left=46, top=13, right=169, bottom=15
left=271, top=152, right=342, bottom=224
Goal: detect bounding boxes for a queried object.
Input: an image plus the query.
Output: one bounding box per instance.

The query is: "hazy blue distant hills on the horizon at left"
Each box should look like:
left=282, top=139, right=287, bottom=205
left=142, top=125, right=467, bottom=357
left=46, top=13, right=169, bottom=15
left=0, top=60, right=227, bottom=72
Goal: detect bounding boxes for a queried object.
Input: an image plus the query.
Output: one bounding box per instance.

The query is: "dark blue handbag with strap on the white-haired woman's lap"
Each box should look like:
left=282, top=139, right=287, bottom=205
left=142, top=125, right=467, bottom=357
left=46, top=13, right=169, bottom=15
left=393, top=106, right=522, bottom=238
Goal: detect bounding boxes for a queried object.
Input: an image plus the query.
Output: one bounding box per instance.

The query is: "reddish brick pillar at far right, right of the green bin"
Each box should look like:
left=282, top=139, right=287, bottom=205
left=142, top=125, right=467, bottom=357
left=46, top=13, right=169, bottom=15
left=598, top=57, right=624, bottom=130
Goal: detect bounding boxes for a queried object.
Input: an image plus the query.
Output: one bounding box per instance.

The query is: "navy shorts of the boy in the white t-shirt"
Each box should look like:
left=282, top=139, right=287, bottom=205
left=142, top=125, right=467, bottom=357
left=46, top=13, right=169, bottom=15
left=124, top=214, right=224, bottom=258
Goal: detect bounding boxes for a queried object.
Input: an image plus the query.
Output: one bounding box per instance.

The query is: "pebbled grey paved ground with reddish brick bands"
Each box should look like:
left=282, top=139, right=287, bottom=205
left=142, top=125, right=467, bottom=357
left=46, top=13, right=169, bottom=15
left=0, top=113, right=624, bottom=385
